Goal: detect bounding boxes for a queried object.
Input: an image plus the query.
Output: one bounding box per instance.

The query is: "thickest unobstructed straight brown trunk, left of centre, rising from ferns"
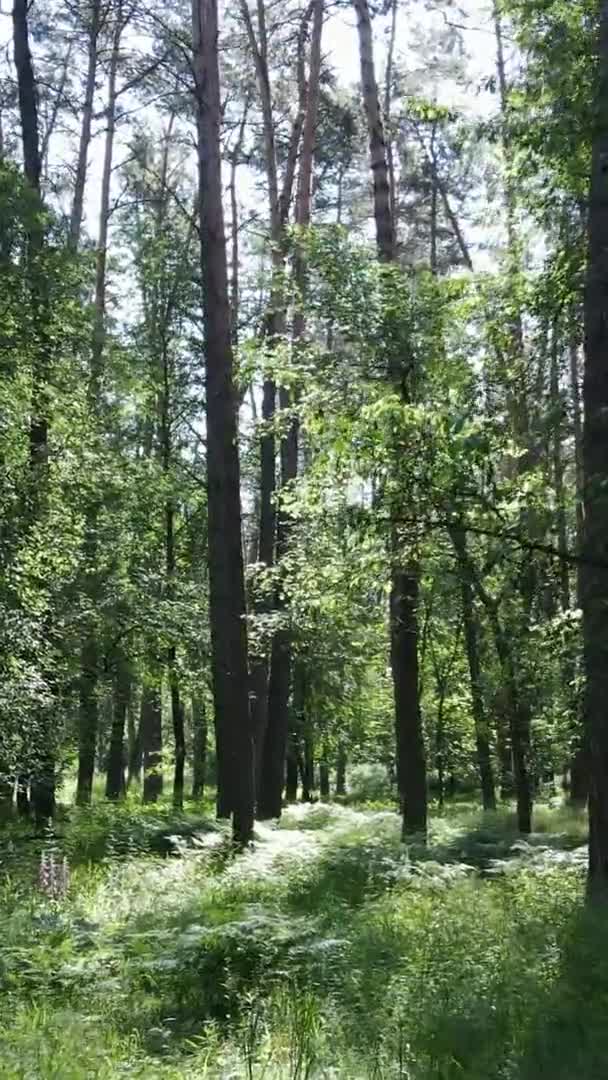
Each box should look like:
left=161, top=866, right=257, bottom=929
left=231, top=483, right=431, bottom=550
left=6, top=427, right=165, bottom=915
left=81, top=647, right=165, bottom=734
left=192, top=0, right=254, bottom=843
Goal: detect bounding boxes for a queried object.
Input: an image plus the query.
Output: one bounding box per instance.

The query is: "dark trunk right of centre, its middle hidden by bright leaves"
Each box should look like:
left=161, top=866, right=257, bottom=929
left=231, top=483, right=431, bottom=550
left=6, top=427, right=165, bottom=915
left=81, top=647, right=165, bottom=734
left=353, top=0, right=427, bottom=835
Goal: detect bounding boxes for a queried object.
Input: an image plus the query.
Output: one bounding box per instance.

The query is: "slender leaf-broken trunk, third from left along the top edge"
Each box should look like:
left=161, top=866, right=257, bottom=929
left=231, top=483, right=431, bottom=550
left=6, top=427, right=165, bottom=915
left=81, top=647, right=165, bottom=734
left=76, top=4, right=123, bottom=806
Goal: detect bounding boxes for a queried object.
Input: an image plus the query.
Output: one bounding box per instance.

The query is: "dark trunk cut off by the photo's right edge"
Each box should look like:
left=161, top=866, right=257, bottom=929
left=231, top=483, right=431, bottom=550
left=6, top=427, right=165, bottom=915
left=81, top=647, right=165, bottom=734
left=581, top=0, right=608, bottom=902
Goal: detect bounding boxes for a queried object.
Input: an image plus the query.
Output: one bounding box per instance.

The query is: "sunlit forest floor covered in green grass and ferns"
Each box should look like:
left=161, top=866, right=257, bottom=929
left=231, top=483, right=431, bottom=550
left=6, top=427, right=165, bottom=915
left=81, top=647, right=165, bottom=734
left=0, top=801, right=608, bottom=1080
